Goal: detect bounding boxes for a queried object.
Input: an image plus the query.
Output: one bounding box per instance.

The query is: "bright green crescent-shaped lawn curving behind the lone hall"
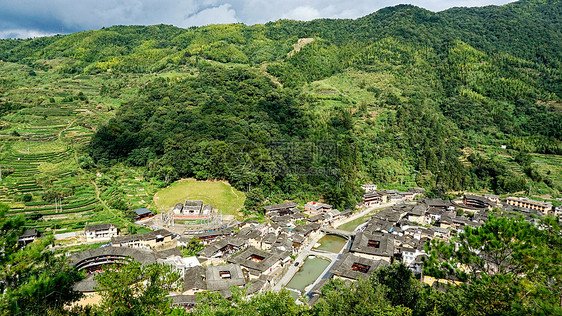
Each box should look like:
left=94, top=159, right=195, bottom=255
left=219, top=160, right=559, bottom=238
left=154, top=179, right=246, bottom=215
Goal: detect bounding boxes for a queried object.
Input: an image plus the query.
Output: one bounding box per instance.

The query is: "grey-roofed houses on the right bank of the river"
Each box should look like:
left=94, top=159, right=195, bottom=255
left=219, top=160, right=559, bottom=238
left=330, top=191, right=562, bottom=285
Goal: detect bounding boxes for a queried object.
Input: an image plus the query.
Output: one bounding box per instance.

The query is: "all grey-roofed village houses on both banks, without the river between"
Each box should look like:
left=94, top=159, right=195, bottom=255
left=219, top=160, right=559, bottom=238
left=18, top=185, right=562, bottom=308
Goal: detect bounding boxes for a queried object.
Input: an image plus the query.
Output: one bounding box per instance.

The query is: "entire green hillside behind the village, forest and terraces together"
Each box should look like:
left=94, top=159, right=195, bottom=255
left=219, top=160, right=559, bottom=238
left=0, top=0, right=562, bottom=229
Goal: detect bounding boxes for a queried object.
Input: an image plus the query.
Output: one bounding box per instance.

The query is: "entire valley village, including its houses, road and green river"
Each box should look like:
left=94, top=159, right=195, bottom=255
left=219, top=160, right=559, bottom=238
left=19, top=184, right=562, bottom=309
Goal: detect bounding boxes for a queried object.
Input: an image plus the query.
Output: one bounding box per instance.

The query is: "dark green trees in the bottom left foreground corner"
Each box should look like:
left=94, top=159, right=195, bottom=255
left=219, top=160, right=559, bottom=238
left=0, top=206, right=81, bottom=315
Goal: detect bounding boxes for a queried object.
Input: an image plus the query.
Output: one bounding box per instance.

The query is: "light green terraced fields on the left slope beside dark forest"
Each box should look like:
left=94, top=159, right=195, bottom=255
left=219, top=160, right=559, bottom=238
left=0, top=61, right=159, bottom=232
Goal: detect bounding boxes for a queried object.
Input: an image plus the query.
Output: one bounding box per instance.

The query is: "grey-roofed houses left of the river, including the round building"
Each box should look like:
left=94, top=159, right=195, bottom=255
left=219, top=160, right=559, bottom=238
left=65, top=201, right=351, bottom=307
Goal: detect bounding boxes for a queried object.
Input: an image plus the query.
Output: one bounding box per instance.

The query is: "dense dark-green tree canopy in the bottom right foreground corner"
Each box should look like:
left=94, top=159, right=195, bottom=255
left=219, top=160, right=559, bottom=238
left=424, top=216, right=562, bottom=315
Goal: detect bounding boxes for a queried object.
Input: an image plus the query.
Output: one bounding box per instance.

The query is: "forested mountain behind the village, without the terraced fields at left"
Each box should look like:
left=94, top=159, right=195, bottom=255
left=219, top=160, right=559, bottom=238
left=0, top=0, right=562, bottom=207
